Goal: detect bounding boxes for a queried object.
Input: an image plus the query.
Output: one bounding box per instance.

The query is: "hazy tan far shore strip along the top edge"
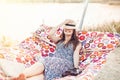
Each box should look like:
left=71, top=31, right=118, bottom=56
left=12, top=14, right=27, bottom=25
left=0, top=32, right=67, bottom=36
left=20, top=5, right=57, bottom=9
left=0, top=0, right=120, bottom=4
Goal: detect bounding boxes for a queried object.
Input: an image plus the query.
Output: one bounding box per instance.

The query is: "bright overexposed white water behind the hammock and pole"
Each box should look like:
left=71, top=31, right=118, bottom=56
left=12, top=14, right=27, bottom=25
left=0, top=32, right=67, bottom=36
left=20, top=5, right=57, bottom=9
left=0, top=3, right=120, bottom=41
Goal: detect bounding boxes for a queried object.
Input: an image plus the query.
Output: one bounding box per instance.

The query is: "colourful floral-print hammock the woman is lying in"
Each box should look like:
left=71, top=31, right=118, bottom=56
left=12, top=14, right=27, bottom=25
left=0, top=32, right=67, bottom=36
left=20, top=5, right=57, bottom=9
left=0, top=25, right=120, bottom=80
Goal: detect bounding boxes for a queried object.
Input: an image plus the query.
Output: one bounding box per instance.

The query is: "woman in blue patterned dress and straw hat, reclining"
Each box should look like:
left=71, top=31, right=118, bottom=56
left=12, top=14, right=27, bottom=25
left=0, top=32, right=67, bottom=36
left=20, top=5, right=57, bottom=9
left=13, top=20, right=81, bottom=80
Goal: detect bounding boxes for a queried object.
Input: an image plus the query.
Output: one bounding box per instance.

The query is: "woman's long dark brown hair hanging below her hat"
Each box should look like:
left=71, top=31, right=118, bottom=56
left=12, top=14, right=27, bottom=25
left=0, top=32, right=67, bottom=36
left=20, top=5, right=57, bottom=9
left=57, top=29, right=79, bottom=50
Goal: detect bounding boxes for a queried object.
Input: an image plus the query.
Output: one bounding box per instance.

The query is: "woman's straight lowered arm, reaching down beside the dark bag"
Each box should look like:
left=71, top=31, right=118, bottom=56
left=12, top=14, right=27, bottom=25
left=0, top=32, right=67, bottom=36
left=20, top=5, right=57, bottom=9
left=73, top=43, right=81, bottom=68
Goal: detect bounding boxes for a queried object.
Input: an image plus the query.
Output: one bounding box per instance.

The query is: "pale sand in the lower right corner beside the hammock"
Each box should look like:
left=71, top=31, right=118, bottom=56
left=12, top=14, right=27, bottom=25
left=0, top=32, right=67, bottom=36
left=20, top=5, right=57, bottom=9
left=95, top=47, right=120, bottom=80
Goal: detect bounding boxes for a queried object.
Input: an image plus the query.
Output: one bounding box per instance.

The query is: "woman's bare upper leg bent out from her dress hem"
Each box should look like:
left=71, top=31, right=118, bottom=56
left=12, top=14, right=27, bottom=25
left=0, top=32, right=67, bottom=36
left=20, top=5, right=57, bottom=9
left=23, top=62, right=44, bottom=77
